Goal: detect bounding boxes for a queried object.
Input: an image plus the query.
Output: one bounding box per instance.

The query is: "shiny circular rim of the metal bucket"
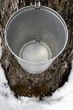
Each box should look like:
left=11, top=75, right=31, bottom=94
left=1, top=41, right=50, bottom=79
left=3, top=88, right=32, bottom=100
left=4, top=5, right=68, bottom=64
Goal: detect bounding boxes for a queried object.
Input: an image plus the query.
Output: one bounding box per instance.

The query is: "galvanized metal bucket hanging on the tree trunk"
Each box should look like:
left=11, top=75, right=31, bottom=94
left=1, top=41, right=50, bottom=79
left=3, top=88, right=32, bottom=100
left=5, top=5, right=68, bottom=74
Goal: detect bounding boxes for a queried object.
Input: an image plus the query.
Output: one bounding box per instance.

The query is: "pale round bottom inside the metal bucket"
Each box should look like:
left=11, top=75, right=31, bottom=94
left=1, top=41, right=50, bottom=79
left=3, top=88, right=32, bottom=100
left=19, top=40, right=52, bottom=62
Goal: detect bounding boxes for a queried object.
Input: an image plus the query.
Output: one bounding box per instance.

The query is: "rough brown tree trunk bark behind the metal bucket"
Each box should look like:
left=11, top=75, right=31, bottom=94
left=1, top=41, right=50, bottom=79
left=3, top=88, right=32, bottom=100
left=0, top=0, right=73, bottom=97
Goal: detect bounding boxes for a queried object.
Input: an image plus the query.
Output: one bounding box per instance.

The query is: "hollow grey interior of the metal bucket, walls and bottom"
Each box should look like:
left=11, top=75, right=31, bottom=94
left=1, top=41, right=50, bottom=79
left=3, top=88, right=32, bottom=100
left=6, top=8, right=66, bottom=61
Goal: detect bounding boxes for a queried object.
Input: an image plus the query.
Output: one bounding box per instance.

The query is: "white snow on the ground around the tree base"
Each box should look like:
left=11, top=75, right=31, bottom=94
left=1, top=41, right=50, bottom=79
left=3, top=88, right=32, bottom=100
left=0, top=38, right=73, bottom=110
